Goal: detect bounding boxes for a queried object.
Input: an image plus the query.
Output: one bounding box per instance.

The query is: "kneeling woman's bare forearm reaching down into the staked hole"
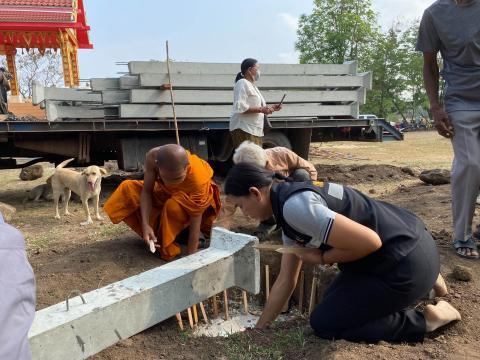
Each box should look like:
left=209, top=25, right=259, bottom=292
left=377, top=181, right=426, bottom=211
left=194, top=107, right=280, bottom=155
left=256, top=254, right=302, bottom=329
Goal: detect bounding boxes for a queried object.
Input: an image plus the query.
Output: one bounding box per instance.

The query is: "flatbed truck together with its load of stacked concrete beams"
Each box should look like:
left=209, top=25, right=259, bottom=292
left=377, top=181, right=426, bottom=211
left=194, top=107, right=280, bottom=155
left=0, top=61, right=401, bottom=171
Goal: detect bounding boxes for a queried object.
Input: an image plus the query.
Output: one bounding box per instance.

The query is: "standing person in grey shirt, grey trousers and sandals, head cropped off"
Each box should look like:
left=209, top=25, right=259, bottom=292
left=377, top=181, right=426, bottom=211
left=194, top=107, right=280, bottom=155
left=417, top=0, right=480, bottom=259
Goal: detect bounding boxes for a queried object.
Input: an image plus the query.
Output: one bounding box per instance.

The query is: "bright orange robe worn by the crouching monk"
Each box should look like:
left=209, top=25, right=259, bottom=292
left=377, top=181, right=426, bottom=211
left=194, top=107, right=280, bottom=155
left=103, top=151, right=220, bottom=260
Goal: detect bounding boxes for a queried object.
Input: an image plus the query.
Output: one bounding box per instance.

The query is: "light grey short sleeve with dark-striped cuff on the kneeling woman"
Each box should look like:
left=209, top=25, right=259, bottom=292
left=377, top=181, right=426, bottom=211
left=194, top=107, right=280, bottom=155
left=282, top=191, right=336, bottom=248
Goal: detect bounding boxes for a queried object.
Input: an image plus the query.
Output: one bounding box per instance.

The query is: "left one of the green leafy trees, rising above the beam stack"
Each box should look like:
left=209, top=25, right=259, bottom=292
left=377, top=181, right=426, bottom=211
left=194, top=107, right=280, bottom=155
left=295, top=0, right=378, bottom=65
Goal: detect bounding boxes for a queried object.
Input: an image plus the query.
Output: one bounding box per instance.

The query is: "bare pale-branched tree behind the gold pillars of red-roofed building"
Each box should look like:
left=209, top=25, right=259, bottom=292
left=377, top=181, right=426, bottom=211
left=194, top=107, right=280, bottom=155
left=2, top=50, right=63, bottom=99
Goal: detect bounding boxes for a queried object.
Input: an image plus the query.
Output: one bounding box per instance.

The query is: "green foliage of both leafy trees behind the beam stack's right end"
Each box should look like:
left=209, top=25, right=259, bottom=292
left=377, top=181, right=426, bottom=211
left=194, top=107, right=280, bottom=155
left=296, top=0, right=428, bottom=119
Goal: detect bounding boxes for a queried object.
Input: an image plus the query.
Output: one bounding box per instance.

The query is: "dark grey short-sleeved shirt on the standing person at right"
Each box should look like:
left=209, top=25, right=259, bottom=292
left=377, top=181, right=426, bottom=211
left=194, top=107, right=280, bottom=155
left=417, top=0, right=480, bottom=112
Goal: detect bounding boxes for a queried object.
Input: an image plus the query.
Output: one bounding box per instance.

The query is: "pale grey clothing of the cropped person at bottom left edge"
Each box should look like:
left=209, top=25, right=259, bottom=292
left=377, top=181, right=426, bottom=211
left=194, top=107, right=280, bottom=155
left=0, top=213, right=35, bottom=360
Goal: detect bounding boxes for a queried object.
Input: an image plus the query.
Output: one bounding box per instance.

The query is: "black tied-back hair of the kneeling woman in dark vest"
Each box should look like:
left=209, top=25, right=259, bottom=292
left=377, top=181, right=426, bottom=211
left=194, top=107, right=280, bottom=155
left=224, top=163, right=286, bottom=196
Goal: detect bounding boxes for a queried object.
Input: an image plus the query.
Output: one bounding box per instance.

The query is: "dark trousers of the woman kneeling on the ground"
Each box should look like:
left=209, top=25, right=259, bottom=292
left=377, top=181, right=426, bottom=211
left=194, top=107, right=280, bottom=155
left=310, top=231, right=440, bottom=342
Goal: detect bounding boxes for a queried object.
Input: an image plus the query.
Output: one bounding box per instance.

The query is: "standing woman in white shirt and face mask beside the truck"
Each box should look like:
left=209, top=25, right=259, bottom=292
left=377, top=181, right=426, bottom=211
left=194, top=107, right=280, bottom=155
left=230, top=58, right=282, bottom=149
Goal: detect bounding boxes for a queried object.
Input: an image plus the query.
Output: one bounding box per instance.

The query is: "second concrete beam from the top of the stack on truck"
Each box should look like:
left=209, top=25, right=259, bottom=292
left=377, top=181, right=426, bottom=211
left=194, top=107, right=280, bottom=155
left=139, top=74, right=364, bottom=89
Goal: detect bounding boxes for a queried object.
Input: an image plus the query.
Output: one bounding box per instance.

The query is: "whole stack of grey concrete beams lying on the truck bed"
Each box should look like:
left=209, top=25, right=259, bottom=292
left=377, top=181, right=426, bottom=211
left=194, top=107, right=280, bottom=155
left=33, top=61, right=371, bottom=121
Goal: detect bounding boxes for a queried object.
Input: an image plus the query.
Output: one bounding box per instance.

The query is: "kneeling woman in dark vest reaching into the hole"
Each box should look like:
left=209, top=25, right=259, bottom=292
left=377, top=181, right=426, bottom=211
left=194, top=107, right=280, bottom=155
left=225, top=163, right=460, bottom=342
